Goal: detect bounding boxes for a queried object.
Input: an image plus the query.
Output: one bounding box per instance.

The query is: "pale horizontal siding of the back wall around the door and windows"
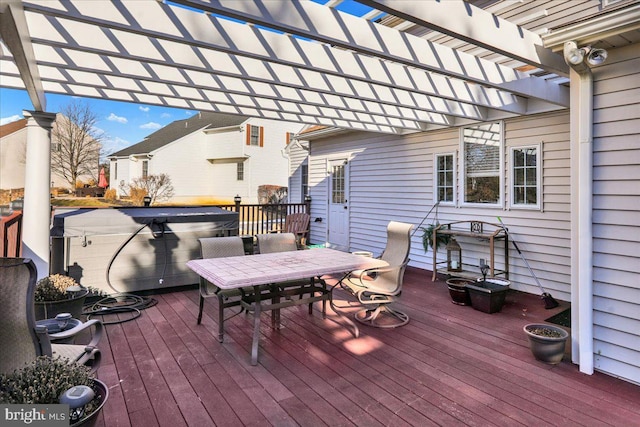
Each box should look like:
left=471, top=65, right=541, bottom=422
left=310, top=112, right=570, bottom=301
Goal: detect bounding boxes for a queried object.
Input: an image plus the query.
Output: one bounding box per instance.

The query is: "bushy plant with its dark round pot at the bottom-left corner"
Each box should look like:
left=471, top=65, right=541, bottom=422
left=0, top=356, right=109, bottom=427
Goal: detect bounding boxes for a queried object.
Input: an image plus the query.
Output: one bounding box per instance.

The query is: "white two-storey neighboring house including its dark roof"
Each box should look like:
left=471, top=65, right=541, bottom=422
left=108, top=112, right=302, bottom=203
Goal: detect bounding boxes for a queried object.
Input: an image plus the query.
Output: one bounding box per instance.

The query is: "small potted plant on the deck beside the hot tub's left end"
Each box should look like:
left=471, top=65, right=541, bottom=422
left=35, top=274, right=89, bottom=320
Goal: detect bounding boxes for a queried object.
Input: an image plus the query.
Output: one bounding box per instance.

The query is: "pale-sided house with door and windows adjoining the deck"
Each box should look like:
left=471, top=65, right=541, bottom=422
left=289, top=7, right=640, bottom=383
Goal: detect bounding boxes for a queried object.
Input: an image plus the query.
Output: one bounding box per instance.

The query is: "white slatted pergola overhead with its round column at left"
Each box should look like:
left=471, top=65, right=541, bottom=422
left=0, top=0, right=569, bottom=276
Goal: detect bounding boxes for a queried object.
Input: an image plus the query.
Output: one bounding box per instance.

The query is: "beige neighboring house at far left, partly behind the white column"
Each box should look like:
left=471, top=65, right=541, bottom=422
left=0, top=114, right=98, bottom=190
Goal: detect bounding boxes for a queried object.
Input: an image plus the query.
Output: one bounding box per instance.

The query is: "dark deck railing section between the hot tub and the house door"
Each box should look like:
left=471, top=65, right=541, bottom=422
left=218, top=203, right=309, bottom=236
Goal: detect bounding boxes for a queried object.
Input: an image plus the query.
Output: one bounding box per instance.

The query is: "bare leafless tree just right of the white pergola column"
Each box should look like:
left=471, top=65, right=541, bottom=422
left=51, top=101, right=105, bottom=189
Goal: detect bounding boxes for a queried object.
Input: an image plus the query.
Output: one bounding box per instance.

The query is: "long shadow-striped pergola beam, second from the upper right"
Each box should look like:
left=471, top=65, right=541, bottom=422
left=173, top=0, right=569, bottom=107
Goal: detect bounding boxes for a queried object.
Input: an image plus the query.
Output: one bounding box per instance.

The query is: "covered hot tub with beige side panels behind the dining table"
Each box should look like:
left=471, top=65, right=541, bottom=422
left=51, top=206, right=238, bottom=293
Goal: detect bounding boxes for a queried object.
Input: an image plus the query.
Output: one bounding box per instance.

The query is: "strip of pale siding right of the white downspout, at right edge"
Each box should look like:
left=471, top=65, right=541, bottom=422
left=593, top=44, right=640, bottom=383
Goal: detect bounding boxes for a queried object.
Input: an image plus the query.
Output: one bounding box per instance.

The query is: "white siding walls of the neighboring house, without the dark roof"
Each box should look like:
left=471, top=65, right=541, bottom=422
left=112, top=119, right=302, bottom=204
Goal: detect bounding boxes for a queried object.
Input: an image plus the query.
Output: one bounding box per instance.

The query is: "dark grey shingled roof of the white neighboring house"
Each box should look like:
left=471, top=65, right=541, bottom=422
left=108, top=112, right=249, bottom=157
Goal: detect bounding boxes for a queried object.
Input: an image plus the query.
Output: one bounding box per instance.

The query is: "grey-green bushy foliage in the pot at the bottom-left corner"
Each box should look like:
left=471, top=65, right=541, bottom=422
left=0, top=356, right=101, bottom=414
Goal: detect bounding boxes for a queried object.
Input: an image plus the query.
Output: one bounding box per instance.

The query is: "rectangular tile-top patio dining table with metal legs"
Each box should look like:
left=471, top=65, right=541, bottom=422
left=187, top=248, right=388, bottom=365
